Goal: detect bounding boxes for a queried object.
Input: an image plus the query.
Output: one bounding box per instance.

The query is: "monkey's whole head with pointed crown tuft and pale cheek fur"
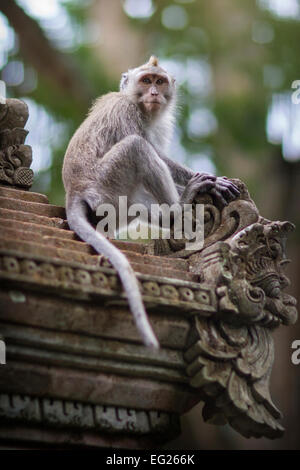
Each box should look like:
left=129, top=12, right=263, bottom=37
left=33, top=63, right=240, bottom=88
left=120, top=56, right=176, bottom=116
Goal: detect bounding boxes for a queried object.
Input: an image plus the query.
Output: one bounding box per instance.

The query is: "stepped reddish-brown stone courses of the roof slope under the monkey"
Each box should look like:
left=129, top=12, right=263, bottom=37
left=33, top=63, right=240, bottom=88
left=0, top=186, right=199, bottom=282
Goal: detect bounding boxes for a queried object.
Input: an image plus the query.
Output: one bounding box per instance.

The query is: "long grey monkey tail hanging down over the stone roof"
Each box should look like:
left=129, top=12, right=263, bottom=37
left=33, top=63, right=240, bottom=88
left=67, top=196, right=159, bottom=349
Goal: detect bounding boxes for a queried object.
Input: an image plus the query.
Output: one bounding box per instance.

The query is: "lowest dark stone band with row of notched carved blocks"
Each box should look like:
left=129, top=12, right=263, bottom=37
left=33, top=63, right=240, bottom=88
left=0, top=393, right=180, bottom=436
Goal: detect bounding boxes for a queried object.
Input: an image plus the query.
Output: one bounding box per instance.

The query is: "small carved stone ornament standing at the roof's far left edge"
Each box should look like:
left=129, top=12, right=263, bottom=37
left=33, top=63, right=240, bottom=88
left=0, top=99, right=33, bottom=189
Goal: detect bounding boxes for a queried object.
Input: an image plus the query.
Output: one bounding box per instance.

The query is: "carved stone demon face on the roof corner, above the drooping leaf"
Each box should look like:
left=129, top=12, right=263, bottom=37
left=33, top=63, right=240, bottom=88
left=218, top=222, right=297, bottom=327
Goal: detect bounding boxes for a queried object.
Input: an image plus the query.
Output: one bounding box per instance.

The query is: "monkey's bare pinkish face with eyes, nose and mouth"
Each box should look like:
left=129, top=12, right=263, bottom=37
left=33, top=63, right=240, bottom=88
left=136, top=72, right=173, bottom=115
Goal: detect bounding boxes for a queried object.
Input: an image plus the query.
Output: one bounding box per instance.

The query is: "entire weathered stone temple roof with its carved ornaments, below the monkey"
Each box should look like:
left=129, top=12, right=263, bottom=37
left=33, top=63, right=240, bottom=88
left=0, top=96, right=297, bottom=448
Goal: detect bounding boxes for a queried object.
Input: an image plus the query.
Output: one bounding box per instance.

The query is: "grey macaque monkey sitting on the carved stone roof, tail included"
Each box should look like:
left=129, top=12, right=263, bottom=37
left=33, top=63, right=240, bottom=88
left=63, top=56, right=239, bottom=348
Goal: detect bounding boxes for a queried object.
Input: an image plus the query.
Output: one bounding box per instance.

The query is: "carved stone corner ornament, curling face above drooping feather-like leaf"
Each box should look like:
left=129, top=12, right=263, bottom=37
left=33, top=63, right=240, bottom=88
left=185, top=205, right=297, bottom=439
